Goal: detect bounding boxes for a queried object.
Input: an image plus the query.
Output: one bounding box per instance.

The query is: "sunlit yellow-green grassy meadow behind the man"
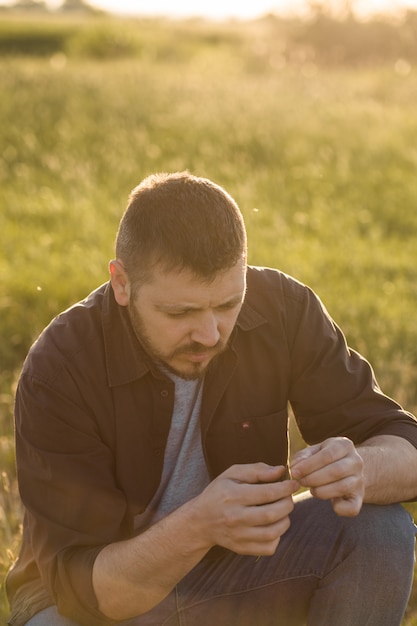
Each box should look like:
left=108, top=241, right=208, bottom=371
left=0, top=11, right=417, bottom=626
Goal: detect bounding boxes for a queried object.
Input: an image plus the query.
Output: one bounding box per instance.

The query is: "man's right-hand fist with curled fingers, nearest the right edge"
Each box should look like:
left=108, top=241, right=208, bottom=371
left=291, top=437, right=365, bottom=517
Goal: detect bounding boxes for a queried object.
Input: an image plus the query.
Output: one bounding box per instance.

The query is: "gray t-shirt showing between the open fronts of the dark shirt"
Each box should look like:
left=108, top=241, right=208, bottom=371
left=135, top=372, right=210, bottom=532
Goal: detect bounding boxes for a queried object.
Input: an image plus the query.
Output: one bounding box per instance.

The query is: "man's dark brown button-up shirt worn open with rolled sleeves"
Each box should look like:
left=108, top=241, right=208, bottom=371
left=7, top=267, right=417, bottom=626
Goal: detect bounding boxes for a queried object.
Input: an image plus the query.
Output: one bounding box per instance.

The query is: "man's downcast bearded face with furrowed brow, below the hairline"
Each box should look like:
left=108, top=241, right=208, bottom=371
left=129, top=261, right=246, bottom=379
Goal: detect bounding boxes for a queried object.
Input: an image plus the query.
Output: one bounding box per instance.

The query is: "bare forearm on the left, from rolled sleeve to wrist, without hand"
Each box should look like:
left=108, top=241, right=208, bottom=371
left=93, top=503, right=210, bottom=621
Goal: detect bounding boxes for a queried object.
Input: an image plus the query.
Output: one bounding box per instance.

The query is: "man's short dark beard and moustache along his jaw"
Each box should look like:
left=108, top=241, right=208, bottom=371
left=128, top=301, right=227, bottom=380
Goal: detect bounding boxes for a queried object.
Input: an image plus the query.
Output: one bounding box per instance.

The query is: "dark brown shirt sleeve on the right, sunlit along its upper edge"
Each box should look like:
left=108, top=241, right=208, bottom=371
left=290, top=287, right=417, bottom=447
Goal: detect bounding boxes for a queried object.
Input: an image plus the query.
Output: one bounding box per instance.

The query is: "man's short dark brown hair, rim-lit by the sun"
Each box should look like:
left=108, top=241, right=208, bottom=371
left=116, top=172, right=247, bottom=287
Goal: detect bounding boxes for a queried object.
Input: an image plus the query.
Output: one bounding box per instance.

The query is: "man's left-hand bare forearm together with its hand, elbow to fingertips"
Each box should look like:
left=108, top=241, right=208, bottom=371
left=93, top=463, right=299, bottom=621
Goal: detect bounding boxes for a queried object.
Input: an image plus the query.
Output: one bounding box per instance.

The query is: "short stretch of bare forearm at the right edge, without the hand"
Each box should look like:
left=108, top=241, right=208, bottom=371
left=357, top=435, right=417, bottom=504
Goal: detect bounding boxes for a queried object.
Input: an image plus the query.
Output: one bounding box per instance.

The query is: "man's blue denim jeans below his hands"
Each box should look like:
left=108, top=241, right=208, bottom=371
left=26, top=494, right=416, bottom=626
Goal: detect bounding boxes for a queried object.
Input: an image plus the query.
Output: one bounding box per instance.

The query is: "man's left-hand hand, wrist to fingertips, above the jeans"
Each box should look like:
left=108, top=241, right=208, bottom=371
left=192, top=463, right=299, bottom=555
